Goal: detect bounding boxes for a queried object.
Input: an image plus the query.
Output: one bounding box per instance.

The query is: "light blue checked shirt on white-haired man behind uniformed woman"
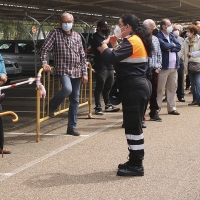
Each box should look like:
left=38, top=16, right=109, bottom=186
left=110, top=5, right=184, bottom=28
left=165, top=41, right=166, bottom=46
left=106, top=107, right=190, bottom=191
left=149, top=35, right=162, bottom=69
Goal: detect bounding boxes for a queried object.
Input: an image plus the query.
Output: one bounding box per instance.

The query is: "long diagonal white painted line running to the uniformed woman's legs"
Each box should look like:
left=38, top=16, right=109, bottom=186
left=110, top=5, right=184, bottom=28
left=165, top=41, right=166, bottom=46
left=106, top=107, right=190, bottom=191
left=0, top=119, right=122, bottom=181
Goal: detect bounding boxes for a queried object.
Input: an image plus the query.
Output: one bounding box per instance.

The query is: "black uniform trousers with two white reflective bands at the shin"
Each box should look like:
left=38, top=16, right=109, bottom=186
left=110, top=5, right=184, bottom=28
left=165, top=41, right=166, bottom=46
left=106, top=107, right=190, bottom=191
left=118, top=76, right=152, bottom=166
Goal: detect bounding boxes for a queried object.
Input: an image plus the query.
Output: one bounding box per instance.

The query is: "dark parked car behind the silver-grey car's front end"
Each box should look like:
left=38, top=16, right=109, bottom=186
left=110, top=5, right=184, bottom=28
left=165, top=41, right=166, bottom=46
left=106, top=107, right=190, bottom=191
left=0, top=40, right=53, bottom=75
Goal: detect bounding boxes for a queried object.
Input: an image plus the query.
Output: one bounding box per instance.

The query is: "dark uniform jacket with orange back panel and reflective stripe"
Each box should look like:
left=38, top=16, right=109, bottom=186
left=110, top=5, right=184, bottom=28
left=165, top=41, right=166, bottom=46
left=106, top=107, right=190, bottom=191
left=101, top=35, right=148, bottom=77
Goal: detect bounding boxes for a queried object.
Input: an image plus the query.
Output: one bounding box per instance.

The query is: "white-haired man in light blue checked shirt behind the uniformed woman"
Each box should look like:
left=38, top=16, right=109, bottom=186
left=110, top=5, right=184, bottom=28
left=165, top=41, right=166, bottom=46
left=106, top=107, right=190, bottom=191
left=143, top=19, right=162, bottom=122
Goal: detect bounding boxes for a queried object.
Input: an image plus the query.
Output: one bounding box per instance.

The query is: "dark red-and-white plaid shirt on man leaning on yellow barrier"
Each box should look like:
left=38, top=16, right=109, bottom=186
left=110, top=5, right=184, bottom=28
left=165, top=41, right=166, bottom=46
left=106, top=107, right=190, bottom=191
left=41, top=28, right=87, bottom=78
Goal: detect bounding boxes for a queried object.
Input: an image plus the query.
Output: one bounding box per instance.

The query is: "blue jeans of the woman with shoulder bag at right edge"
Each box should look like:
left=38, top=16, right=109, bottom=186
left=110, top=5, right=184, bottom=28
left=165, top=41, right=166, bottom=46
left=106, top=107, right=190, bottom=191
left=188, top=72, right=200, bottom=103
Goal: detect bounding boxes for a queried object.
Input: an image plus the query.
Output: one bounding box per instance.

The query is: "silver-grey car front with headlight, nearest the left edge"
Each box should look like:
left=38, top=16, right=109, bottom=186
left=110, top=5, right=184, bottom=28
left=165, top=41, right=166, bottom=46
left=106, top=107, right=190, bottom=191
left=2, top=56, right=23, bottom=84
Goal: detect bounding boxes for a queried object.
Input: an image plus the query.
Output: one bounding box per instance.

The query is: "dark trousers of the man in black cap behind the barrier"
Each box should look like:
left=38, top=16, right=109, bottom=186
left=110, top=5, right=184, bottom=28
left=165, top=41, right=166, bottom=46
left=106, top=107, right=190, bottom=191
left=94, top=69, right=114, bottom=107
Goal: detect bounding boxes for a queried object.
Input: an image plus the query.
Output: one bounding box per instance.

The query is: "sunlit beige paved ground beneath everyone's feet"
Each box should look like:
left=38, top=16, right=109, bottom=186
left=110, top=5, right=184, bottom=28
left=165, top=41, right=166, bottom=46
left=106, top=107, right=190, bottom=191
left=0, top=91, right=200, bottom=200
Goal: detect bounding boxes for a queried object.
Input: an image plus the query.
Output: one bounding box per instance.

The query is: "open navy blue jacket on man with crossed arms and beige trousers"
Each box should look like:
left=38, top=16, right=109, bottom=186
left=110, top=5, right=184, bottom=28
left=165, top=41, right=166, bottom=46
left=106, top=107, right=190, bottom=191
left=157, top=31, right=181, bottom=70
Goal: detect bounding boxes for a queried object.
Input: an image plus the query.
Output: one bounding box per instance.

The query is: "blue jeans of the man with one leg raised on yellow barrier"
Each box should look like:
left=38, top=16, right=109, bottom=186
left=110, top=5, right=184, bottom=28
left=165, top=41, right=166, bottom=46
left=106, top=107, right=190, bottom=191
left=50, top=75, right=81, bottom=129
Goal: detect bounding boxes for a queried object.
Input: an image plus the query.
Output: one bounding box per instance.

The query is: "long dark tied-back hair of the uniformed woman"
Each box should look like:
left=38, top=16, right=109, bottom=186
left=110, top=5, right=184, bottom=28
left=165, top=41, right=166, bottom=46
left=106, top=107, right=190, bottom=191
left=121, top=14, right=153, bottom=56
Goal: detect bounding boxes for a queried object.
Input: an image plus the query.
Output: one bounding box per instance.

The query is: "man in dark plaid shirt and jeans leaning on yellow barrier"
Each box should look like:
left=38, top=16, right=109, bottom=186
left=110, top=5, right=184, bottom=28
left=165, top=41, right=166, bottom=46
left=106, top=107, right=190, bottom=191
left=41, top=12, right=88, bottom=136
